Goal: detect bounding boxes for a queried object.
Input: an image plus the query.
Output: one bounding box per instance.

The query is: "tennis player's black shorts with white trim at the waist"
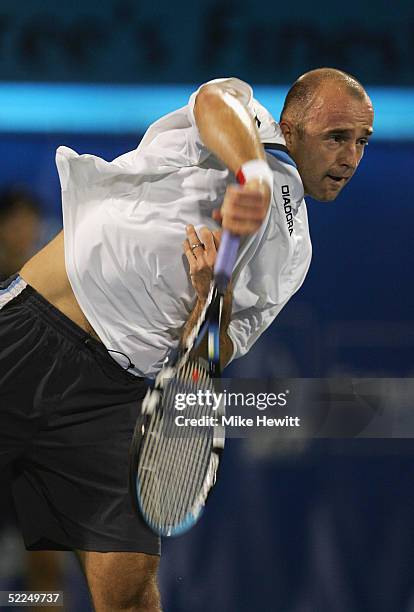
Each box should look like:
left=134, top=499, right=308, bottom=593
left=0, top=277, right=160, bottom=554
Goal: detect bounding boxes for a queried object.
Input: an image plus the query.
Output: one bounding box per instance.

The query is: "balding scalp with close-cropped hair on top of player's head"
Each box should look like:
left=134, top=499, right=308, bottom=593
left=280, top=68, right=367, bottom=129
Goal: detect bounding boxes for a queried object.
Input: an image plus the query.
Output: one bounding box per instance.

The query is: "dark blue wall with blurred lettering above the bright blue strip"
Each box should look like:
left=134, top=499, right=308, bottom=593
left=0, top=0, right=414, bottom=85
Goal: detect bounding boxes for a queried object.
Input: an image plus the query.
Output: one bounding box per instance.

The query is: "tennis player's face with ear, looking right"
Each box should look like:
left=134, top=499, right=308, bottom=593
left=281, top=83, right=374, bottom=202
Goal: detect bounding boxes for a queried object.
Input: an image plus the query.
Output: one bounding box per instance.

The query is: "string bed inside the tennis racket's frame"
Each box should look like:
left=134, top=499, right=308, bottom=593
left=138, top=363, right=218, bottom=527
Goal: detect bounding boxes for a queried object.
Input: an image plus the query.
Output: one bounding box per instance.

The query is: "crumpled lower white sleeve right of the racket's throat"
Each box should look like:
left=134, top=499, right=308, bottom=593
left=227, top=300, right=288, bottom=363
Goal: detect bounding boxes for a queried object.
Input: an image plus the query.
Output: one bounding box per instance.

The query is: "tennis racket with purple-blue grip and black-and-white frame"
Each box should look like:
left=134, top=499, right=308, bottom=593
left=130, top=231, right=240, bottom=536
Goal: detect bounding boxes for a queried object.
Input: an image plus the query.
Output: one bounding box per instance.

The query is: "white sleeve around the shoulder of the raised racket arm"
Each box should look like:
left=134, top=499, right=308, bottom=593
left=187, top=77, right=254, bottom=161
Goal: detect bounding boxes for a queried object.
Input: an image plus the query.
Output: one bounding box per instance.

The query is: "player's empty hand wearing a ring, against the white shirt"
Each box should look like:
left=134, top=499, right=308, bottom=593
left=183, top=225, right=221, bottom=302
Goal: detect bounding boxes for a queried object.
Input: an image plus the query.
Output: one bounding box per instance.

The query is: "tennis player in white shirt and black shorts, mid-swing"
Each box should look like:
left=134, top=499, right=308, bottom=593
left=0, top=69, right=373, bottom=612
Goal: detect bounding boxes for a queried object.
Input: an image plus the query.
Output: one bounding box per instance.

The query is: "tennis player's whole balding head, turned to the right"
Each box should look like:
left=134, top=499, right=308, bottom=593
left=280, top=68, right=374, bottom=202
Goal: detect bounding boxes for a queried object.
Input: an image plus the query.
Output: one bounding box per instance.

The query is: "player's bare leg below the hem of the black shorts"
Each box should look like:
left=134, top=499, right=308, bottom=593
left=76, top=551, right=161, bottom=612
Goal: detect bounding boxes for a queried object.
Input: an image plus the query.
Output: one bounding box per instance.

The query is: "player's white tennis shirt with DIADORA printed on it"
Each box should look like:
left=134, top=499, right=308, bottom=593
left=56, top=78, right=311, bottom=377
